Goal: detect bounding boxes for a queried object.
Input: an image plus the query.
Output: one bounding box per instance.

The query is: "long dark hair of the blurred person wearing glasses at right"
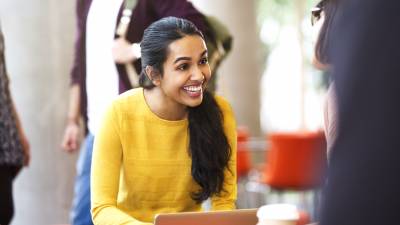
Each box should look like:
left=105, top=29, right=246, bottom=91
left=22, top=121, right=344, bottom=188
left=315, top=0, right=338, bottom=65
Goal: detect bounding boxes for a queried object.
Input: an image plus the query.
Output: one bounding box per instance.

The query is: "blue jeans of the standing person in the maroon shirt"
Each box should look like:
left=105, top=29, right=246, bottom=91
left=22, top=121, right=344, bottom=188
left=70, top=134, right=94, bottom=225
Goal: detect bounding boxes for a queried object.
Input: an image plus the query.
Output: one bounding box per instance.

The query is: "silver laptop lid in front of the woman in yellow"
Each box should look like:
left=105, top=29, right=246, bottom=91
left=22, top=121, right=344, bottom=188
left=154, top=209, right=257, bottom=225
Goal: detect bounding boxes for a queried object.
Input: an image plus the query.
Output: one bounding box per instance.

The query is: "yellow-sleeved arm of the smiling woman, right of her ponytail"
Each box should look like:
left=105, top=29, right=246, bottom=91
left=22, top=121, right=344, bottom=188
left=211, top=97, right=237, bottom=210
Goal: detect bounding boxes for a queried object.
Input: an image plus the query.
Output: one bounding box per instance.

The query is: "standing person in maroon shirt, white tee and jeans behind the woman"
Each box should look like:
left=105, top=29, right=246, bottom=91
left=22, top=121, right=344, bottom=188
left=62, top=0, right=209, bottom=225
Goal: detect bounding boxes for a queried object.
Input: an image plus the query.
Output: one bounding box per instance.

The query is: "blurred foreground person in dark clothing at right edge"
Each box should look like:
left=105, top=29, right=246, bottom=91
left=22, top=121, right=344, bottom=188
left=320, top=0, right=400, bottom=225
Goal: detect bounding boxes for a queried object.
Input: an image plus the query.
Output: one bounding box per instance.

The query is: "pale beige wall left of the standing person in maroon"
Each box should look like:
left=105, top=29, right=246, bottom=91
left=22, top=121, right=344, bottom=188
left=0, top=0, right=76, bottom=225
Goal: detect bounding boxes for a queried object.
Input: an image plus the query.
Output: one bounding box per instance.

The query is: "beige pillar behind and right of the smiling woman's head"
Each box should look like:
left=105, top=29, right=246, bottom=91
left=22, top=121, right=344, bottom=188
left=192, top=0, right=263, bottom=136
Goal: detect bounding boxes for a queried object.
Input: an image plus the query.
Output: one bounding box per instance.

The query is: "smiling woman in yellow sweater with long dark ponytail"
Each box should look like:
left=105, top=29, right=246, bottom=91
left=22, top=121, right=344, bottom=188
left=91, top=17, right=237, bottom=224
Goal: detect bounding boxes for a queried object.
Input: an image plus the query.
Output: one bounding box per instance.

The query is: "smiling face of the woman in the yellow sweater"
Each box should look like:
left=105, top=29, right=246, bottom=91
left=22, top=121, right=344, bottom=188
left=159, top=35, right=211, bottom=107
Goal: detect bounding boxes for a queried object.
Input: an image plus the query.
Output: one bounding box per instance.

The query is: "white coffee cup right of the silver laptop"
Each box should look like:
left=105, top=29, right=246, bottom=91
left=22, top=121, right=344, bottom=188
left=257, top=204, right=299, bottom=225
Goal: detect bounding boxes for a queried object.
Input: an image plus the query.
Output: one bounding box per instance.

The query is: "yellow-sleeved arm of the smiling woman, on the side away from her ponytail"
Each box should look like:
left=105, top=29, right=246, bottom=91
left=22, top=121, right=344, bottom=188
left=91, top=105, right=149, bottom=225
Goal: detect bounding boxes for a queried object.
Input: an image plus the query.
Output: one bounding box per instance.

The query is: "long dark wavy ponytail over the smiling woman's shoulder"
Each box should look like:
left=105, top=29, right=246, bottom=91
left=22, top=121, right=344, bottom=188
left=188, top=91, right=232, bottom=203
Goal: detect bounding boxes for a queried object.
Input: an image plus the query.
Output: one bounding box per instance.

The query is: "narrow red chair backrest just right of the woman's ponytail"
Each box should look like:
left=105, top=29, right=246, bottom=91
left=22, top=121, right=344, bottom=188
left=236, top=127, right=251, bottom=178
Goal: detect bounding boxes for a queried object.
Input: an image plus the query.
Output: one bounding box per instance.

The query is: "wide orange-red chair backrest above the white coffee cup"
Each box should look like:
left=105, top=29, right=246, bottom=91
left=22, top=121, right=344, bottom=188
left=264, top=132, right=327, bottom=189
